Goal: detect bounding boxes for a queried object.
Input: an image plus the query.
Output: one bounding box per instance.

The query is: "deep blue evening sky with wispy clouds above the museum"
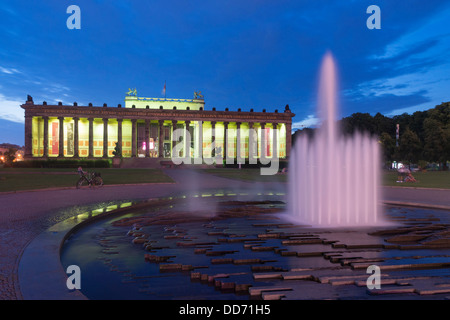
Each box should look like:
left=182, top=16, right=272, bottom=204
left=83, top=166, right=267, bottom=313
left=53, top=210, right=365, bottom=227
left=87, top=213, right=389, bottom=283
left=0, top=0, right=450, bottom=145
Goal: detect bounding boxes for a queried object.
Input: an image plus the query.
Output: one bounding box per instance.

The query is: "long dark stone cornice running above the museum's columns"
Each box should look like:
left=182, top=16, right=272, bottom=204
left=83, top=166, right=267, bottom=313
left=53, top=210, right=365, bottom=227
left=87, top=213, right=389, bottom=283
left=21, top=104, right=295, bottom=123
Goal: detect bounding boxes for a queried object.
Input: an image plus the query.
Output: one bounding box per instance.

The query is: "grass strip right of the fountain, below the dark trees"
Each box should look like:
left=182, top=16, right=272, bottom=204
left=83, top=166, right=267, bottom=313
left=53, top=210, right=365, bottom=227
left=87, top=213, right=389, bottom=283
left=383, top=171, right=450, bottom=189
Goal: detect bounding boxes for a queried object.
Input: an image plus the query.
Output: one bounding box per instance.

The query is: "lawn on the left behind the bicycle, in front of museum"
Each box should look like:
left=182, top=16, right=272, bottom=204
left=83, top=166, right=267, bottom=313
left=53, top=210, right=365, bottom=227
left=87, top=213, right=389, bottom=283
left=0, top=168, right=174, bottom=192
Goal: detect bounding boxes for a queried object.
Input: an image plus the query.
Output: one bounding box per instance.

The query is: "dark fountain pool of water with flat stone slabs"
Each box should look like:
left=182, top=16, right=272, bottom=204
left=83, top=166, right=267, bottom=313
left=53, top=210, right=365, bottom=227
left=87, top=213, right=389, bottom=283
left=61, top=199, right=450, bottom=300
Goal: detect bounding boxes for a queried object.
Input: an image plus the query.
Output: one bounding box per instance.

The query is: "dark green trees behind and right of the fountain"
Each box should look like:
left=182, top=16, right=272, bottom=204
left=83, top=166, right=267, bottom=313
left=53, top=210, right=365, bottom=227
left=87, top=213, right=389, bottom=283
left=293, top=102, right=450, bottom=170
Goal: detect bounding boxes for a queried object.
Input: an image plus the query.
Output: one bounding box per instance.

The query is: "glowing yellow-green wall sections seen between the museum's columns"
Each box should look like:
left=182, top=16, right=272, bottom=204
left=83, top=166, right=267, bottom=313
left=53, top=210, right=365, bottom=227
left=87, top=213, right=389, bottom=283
left=31, top=117, right=287, bottom=163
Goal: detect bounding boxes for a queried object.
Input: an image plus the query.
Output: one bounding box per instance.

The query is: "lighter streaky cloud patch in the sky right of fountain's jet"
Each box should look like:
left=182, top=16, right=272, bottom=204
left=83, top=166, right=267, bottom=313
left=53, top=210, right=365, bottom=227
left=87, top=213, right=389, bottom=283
left=350, top=3, right=450, bottom=116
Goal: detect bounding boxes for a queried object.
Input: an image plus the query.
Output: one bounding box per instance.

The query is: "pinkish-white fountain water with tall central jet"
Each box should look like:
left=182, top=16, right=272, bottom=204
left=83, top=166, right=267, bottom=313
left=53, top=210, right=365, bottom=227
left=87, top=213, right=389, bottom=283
left=288, top=53, right=381, bottom=227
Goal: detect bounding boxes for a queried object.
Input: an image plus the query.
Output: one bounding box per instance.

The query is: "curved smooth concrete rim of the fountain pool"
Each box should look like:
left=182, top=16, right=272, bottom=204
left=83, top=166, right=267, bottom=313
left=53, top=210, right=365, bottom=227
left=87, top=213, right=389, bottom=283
left=18, top=197, right=450, bottom=300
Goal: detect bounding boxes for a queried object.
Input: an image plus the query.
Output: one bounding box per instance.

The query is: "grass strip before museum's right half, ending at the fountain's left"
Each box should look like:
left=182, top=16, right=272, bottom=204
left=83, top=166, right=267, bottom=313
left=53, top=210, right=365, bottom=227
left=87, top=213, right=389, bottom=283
left=202, top=168, right=287, bottom=182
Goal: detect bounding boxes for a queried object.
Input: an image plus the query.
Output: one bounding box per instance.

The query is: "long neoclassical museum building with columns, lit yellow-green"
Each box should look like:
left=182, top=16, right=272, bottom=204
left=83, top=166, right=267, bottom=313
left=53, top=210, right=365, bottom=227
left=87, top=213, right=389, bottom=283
left=21, top=90, right=294, bottom=163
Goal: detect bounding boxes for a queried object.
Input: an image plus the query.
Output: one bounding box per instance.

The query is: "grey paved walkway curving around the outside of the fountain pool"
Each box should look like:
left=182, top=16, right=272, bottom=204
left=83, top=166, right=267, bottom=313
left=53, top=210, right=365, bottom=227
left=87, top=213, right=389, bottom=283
left=0, top=169, right=450, bottom=300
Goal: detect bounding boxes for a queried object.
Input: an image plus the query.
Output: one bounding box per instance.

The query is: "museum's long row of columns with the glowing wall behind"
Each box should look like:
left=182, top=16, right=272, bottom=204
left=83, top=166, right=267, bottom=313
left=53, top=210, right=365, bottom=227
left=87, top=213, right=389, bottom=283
left=25, top=116, right=291, bottom=158
